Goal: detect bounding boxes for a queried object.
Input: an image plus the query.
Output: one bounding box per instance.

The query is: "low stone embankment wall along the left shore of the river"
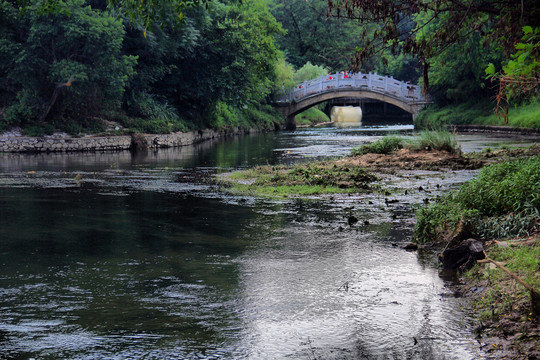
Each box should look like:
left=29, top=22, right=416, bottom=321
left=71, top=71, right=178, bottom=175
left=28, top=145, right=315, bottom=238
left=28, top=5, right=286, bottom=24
left=0, top=129, right=259, bottom=152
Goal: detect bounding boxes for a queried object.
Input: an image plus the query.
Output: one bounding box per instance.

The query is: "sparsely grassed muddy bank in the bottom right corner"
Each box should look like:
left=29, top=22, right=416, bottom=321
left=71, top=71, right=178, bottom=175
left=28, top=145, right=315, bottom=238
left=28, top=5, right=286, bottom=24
left=463, top=240, right=540, bottom=359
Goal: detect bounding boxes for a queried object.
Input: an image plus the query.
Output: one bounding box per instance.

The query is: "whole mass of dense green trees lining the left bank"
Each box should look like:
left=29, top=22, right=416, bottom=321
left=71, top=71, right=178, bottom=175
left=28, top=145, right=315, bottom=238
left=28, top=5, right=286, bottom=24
left=0, top=0, right=286, bottom=133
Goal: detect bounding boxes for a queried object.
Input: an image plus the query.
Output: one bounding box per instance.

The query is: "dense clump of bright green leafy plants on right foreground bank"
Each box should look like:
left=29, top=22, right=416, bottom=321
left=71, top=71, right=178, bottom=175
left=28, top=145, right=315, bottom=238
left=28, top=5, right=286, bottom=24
left=415, top=155, right=540, bottom=242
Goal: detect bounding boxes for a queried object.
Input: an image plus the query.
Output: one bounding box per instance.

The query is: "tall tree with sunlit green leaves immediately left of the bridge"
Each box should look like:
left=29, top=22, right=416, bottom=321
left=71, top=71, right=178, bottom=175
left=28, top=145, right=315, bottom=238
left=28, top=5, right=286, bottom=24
left=190, top=0, right=281, bottom=107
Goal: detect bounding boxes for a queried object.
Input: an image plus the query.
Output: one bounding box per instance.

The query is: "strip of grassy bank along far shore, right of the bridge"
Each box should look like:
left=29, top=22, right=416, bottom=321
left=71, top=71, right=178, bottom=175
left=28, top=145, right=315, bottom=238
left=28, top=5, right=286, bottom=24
left=415, top=100, right=540, bottom=129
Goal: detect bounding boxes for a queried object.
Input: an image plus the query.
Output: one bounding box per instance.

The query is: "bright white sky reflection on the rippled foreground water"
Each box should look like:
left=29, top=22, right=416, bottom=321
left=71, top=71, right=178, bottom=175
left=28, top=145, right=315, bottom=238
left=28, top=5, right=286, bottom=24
left=236, top=207, right=480, bottom=360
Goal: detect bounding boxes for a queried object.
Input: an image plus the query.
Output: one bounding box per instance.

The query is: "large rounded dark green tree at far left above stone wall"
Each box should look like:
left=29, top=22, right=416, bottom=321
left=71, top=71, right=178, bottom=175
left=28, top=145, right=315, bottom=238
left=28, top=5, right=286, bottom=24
left=0, top=0, right=136, bottom=125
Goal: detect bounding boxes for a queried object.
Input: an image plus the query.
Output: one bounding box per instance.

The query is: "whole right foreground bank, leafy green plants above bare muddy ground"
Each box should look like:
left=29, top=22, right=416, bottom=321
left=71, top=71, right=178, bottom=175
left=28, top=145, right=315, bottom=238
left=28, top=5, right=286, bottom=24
left=414, top=155, right=540, bottom=359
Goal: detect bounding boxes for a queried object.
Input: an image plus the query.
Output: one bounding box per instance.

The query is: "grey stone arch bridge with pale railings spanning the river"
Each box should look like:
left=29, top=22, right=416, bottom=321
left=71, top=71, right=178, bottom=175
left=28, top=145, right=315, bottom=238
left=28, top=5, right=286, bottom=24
left=274, top=73, right=429, bottom=130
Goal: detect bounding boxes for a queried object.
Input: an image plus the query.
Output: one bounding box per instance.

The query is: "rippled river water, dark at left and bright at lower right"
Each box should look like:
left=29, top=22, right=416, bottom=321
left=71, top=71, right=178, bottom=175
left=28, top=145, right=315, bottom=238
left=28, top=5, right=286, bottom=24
left=0, top=125, right=532, bottom=359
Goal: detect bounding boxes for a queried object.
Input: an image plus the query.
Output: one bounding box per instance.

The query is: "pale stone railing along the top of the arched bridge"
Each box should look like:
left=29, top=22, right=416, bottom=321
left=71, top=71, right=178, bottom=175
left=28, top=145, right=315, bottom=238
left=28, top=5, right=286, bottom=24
left=276, top=72, right=426, bottom=103
